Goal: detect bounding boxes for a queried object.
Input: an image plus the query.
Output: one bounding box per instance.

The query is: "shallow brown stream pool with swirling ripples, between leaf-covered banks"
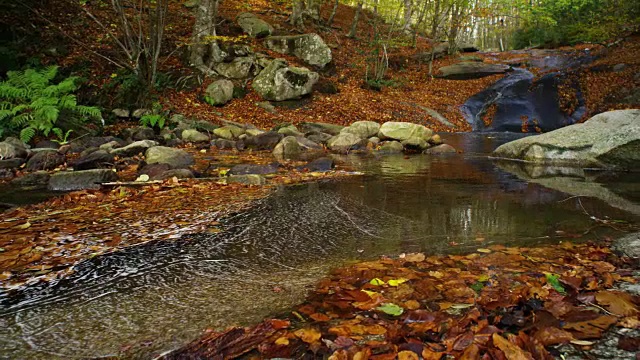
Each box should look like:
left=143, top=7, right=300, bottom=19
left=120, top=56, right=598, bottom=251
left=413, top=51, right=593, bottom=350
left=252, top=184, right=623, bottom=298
left=0, top=134, right=640, bottom=359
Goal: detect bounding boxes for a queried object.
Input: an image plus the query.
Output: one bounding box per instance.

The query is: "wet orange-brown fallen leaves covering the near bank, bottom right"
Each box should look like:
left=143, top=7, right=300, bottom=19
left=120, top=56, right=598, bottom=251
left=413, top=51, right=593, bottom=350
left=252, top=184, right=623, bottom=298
left=166, top=243, right=640, bottom=360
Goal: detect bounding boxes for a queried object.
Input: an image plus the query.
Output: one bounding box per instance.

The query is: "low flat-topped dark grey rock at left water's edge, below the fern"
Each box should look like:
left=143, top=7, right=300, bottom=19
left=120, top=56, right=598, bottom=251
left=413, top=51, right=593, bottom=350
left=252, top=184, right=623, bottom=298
left=49, top=169, right=118, bottom=191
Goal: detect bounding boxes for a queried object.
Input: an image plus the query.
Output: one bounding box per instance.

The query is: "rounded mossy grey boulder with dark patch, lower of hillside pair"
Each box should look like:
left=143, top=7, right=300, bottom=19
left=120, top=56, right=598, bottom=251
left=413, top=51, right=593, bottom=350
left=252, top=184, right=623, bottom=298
left=251, top=59, right=319, bottom=101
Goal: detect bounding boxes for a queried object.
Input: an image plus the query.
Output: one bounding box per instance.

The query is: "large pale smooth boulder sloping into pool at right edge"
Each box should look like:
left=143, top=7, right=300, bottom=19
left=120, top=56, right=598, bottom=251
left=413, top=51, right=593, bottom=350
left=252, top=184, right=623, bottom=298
left=493, top=110, right=640, bottom=171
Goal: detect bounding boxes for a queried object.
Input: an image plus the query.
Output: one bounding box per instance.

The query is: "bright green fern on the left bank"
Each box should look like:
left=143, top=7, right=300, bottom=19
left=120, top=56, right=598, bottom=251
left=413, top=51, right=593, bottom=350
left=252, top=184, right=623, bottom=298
left=0, top=66, right=101, bottom=143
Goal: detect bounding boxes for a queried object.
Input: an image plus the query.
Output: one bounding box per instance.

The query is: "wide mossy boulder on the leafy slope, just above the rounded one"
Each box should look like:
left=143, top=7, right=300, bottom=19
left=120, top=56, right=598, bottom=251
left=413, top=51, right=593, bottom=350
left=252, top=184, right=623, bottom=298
left=265, top=34, right=332, bottom=68
